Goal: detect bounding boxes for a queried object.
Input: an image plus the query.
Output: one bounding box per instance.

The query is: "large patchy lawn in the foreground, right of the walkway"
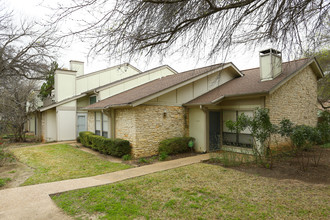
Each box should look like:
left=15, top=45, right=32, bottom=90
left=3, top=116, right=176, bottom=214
left=52, top=164, right=330, bottom=219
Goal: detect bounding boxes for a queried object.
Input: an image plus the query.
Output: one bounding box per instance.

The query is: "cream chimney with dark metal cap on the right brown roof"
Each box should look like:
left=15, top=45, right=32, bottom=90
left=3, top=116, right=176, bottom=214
left=259, top=48, right=282, bottom=81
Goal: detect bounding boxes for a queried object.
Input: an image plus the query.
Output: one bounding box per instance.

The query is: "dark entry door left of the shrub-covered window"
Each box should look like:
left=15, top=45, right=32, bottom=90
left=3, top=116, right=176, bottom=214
left=209, top=111, right=220, bottom=151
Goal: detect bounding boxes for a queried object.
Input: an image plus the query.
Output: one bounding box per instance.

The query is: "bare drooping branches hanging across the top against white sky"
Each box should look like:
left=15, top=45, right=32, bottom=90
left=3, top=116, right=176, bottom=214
left=55, top=0, right=330, bottom=60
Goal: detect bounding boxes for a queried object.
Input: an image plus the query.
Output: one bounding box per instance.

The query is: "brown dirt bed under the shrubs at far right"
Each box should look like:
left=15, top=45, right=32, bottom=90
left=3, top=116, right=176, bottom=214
left=206, top=147, right=330, bottom=185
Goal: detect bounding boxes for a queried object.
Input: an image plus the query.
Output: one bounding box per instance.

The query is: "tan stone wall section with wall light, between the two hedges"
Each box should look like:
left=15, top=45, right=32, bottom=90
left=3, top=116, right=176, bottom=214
left=115, top=106, right=188, bottom=157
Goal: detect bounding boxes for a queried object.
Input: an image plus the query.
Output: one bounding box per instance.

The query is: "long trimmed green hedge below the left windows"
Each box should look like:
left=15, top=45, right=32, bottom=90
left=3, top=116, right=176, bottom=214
left=79, top=131, right=131, bottom=157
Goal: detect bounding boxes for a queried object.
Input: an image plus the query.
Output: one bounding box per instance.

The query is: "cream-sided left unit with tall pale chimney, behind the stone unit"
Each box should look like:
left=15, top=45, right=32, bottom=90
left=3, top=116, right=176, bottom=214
left=36, top=61, right=177, bottom=142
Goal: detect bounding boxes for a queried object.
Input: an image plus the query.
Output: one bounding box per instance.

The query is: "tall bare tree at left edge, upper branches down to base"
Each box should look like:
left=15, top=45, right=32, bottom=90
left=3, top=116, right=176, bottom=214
left=0, top=0, right=61, bottom=141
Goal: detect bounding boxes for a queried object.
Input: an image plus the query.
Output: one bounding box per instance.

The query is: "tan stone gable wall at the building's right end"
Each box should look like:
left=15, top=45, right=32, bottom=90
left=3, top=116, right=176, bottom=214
left=265, top=67, right=317, bottom=142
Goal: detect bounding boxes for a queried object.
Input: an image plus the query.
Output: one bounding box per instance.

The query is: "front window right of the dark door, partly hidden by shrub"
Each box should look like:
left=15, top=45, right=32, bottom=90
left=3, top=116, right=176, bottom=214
left=222, top=111, right=253, bottom=148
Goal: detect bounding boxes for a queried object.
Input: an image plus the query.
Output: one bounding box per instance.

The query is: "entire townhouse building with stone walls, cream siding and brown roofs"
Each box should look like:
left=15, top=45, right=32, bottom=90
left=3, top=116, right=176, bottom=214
left=29, top=49, right=323, bottom=157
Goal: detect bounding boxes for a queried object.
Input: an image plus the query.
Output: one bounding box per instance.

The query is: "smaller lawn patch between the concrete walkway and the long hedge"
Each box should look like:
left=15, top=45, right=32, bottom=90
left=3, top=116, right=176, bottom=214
left=12, top=144, right=130, bottom=185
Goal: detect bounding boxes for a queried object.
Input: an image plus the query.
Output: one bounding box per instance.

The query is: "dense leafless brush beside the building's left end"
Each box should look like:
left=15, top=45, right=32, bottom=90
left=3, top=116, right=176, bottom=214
left=0, top=76, right=37, bottom=141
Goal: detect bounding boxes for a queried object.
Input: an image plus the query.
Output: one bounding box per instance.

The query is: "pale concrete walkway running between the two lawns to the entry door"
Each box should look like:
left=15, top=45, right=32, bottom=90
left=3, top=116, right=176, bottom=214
left=0, top=154, right=210, bottom=220
